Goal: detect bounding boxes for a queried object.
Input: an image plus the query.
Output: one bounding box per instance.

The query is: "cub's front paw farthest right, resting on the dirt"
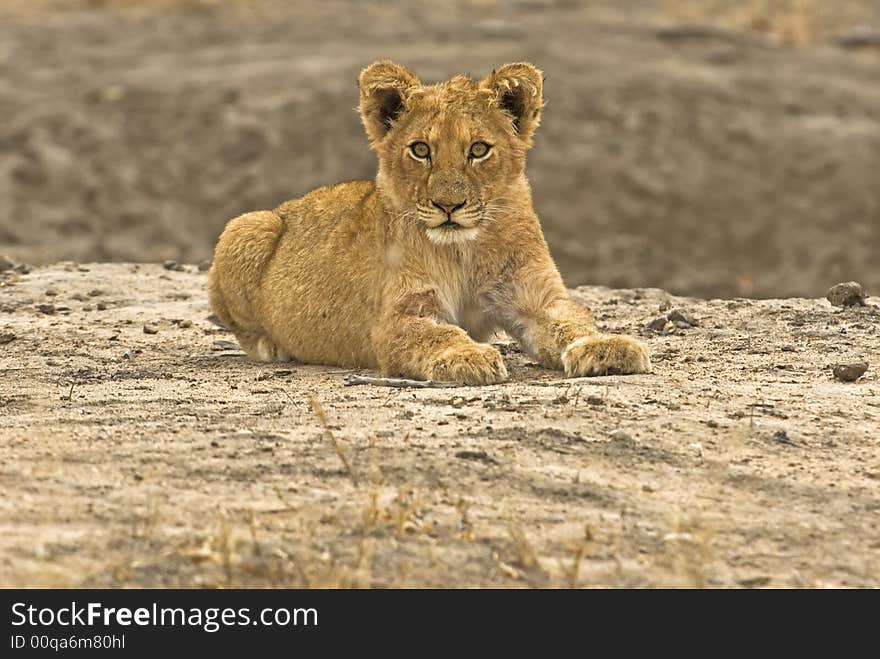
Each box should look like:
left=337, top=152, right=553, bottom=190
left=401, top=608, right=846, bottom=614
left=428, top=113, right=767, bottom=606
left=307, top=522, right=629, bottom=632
left=562, top=334, right=651, bottom=378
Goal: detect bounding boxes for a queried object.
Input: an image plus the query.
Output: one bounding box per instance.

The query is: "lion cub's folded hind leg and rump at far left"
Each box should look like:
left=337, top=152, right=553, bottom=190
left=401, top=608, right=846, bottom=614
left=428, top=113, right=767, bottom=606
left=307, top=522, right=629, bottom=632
left=208, top=211, right=291, bottom=362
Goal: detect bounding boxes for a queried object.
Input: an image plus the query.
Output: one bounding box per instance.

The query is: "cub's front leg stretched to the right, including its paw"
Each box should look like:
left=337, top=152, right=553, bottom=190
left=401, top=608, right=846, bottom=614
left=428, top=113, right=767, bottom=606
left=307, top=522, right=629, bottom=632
left=498, top=263, right=651, bottom=377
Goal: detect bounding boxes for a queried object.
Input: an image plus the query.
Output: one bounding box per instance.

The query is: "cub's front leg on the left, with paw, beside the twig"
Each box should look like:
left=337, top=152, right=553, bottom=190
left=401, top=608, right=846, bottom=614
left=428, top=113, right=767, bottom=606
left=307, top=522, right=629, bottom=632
left=372, top=289, right=507, bottom=385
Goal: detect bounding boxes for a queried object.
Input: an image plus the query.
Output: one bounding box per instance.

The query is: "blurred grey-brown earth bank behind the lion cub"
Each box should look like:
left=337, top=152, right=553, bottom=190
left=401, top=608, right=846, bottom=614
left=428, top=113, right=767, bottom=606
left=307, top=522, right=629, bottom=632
left=0, top=0, right=880, bottom=297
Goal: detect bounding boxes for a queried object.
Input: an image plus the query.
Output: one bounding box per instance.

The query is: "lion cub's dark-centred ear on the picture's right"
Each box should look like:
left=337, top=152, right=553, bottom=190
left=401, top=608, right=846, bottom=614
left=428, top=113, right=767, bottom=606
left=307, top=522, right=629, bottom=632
left=480, top=62, right=544, bottom=145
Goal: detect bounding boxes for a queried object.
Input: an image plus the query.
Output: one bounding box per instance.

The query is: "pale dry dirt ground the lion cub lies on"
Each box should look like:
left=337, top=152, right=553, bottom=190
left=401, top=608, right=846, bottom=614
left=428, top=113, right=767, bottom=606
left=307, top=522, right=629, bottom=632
left=0, top=263, right=880, bottom=587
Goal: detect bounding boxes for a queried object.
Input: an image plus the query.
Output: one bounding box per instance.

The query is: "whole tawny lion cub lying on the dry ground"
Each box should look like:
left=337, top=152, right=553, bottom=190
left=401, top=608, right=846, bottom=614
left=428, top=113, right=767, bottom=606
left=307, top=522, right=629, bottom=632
left=209, top=61, right=651, bottom=384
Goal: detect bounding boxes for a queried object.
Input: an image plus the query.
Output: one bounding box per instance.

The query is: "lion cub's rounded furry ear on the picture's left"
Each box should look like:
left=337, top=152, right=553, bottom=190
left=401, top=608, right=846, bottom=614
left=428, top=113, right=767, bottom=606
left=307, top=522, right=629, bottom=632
left=358, top=60, right=421, bottom=143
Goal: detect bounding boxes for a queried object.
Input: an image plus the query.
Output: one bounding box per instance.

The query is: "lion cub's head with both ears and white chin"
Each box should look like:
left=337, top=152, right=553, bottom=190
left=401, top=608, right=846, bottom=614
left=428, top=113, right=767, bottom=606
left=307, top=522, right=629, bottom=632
left=358, top=61, right=543, bottom=244
